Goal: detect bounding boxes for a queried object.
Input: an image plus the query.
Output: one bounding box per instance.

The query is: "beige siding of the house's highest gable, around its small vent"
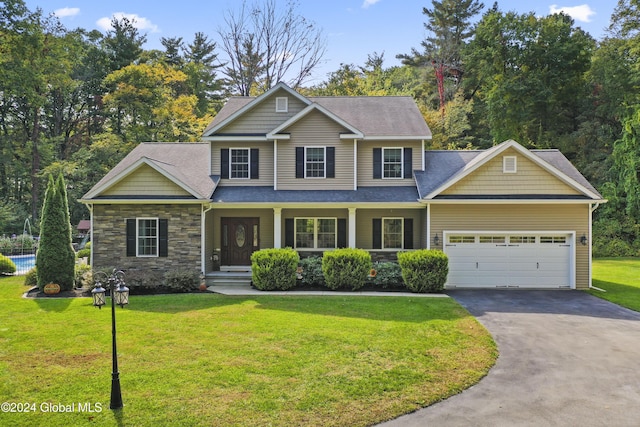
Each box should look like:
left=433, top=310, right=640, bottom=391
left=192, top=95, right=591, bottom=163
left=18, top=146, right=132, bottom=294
left=216, top=90, right=307, bottom=134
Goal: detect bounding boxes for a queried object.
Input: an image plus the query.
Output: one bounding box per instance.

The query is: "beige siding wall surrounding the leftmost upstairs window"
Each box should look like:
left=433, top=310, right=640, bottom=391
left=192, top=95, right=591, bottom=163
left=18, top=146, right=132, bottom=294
left=211, top=141, right=275, bottom=187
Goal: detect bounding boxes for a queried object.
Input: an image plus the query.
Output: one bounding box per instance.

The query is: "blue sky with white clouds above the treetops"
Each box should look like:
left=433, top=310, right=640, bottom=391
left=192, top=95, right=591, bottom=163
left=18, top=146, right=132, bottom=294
left=26, top=0, right=617, bottom=83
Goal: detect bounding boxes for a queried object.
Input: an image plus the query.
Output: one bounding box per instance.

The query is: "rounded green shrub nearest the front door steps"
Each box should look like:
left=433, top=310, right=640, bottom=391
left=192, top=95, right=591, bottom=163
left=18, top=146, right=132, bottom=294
left=251, top=248, right=300, bottom=291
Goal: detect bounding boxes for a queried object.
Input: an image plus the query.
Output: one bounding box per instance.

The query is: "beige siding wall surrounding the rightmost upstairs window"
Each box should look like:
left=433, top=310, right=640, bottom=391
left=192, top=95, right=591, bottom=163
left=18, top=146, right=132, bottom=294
left=358, top=141, right=423, bottom=187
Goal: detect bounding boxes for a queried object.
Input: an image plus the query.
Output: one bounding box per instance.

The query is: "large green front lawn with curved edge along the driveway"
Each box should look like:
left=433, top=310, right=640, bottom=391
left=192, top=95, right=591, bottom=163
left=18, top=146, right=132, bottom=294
left=0, top=277, right=497, bottom=426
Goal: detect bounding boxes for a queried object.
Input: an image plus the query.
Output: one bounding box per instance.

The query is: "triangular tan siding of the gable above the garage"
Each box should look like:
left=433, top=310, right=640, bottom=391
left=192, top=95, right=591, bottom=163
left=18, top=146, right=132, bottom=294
left=442, top=149, right=581, bottom=195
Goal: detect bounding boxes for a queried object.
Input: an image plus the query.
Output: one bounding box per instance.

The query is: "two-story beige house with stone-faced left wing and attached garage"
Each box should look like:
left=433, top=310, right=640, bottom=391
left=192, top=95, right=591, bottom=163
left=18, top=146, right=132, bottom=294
left=82, top=83, right=604, bottom=288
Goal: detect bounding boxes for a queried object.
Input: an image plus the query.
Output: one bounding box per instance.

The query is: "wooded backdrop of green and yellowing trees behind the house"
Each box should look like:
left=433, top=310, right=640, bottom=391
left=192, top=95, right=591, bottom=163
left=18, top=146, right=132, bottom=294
left=0, top=0, right=640, bottom=256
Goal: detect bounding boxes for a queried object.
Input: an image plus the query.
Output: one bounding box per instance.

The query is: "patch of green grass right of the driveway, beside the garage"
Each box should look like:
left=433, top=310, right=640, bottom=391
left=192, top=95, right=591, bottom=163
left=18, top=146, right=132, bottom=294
left=588, top=258, right=640, bottom=311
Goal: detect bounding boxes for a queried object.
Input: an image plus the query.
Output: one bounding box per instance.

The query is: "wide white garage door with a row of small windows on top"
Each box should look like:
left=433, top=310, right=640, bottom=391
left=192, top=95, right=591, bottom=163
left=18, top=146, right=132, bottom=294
left=444, top=232, right=574, bottom=288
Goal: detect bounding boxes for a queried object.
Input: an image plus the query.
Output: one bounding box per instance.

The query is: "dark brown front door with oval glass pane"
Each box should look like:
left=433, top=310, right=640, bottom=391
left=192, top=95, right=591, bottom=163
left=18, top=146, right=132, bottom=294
left=220, top=218, right=260, bottom=265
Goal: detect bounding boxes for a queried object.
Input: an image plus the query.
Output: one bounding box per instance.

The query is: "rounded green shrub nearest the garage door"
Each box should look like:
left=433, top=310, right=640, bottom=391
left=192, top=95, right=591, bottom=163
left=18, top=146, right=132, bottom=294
left=398, top=249, right=449, bottom=292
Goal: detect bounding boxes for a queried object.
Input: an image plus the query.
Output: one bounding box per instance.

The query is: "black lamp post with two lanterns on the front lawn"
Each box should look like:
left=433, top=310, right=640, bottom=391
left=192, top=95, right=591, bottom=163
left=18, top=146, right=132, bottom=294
left=91, top=270, right=129, bottom=409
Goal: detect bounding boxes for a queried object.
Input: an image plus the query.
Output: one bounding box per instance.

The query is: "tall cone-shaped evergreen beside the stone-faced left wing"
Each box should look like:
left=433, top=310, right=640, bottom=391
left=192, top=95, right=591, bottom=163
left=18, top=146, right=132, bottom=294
left=36, top=175, right=75, bottom=290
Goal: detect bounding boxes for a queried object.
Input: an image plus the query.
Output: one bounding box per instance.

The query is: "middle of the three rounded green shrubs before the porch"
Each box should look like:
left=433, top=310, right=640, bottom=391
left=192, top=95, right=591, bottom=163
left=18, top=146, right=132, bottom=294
left=322, top=248, right=371, bottom=291
